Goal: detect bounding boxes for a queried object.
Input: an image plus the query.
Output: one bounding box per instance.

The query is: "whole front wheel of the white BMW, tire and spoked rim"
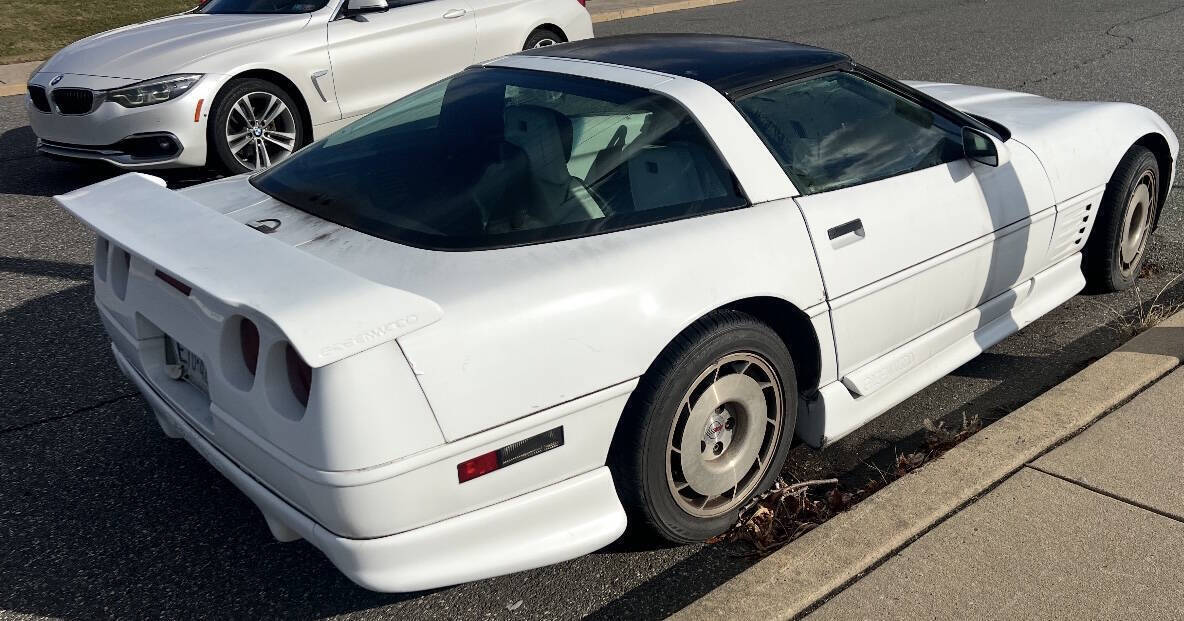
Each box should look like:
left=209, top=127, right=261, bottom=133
left=210, top=78, right=305, bottom=174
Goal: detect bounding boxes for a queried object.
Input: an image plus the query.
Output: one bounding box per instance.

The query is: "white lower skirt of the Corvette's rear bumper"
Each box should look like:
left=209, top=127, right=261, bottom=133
left=112, top=347, right=625, bottom=593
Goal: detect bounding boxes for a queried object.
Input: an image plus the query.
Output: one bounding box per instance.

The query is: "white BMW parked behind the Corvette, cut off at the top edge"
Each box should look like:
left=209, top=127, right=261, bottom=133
left=19, top=0, right=592, bottom=173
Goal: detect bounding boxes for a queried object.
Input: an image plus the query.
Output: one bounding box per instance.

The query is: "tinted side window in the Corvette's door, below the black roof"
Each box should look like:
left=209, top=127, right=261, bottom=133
left=739, top=72, right=963, bottom=194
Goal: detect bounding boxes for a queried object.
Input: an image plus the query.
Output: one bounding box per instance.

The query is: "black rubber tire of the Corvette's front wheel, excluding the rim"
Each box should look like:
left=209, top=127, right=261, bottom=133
left=1081, top=145, right=1159, bottom=293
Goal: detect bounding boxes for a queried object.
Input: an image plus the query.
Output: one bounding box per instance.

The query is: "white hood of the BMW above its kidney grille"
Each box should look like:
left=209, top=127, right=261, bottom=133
left=41, top=13, right=310, bottom=79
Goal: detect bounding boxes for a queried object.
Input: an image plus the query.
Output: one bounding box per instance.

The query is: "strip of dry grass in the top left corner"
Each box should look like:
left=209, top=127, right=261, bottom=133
left=0, top=0, right=197, bottom=64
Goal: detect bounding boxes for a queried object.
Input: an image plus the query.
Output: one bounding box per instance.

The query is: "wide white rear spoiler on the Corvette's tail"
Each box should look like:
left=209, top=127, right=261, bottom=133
left=53, top=173, right=444, bottom=367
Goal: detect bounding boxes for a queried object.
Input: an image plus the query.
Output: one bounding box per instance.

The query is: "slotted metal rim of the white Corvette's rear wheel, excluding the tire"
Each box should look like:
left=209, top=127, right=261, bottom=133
left=665, top=352, right=784, bottom=518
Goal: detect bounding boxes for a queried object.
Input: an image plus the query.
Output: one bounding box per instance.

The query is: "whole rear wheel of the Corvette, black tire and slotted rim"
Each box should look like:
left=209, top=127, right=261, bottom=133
left=610, top=311, right=797, bottom=543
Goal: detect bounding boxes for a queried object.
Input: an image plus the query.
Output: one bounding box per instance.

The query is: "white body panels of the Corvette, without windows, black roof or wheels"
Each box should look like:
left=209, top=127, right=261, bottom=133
left=58, top=35, right=1178, bottom=591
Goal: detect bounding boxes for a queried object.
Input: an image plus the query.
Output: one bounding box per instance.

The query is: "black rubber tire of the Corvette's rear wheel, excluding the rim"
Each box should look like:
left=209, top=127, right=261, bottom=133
left=609, top=311, right=798, bottom=543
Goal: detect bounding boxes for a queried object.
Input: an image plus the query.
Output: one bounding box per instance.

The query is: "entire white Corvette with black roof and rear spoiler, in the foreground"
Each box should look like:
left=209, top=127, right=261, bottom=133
left=58, top=36, right=1178, bottom=591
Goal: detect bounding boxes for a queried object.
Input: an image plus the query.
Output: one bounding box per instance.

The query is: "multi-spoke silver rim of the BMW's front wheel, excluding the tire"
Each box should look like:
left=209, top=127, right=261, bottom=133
left=226, top=91, right=296, bottom=171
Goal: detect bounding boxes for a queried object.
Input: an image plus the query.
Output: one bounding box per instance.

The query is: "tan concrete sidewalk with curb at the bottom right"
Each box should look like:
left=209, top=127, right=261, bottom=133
left=674, top=313, right=1184, bottom=621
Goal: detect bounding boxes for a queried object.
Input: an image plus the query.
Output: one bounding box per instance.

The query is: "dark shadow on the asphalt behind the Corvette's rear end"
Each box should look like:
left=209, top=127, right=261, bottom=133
left=0, top=283, right=435, bottom=619
